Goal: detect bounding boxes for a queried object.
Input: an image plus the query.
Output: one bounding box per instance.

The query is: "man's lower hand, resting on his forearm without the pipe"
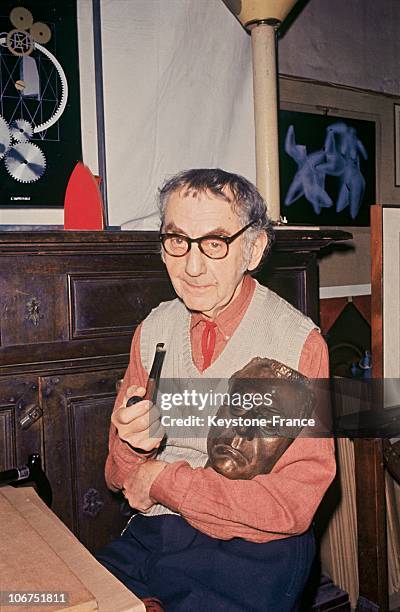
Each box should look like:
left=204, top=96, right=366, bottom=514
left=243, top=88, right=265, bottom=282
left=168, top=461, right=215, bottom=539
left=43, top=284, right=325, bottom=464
left=123, top=459, right=168, bottom=512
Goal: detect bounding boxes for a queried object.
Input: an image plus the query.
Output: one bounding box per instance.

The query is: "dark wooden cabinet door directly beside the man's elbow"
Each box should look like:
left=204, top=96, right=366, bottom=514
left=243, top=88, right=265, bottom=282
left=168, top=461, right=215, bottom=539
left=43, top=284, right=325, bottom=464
left=40, top=368, right=127, bottom=551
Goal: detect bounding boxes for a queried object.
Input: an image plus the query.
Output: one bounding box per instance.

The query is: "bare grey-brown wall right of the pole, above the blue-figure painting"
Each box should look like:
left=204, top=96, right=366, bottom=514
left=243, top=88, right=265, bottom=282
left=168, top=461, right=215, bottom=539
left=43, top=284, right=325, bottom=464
left=279, top=0, right=400, bottom=95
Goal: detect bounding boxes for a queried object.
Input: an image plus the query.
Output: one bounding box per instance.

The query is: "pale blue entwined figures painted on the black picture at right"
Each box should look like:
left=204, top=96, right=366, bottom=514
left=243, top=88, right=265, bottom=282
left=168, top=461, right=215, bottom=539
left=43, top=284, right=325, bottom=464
left=284, top=121, right=368, bottom=219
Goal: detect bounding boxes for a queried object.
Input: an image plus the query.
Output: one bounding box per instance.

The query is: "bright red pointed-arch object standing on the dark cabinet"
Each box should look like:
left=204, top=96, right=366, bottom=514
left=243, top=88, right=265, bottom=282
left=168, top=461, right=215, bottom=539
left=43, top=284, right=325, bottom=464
left=64, top=162, right=104, bottom=230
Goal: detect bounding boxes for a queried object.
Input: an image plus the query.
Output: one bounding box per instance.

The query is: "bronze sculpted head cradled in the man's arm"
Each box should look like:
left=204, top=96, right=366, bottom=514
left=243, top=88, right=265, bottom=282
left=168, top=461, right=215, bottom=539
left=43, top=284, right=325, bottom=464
left=207, top=357, right=314, bottom=480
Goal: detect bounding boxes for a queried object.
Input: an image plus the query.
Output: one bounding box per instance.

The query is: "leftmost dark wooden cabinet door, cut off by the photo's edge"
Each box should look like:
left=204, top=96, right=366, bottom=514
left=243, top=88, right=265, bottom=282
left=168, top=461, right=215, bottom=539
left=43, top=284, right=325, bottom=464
left=0, top=376, right=43, bottom=471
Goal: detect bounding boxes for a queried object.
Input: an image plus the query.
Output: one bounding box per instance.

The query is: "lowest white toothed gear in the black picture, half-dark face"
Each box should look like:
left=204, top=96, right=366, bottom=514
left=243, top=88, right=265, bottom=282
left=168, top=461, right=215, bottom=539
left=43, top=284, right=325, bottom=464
left=4, top=142, right=46, bottom=183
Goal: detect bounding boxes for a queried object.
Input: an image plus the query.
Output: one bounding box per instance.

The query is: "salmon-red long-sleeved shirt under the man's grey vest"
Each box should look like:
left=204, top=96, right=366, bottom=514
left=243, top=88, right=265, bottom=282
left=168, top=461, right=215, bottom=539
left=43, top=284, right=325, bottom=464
left=105, top=276, right=336, bottom=542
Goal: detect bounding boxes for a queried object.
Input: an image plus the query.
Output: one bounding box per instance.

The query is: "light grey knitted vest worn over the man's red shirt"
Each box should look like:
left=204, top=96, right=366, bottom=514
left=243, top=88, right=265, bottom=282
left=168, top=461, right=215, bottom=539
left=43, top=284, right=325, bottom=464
left=140, top=282, right=316, bottom=515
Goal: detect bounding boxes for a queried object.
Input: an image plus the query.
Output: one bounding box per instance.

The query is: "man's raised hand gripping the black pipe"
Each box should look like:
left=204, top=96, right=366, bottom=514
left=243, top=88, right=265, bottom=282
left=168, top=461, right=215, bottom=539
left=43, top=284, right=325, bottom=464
left=111, top=386, right=164, bottom=451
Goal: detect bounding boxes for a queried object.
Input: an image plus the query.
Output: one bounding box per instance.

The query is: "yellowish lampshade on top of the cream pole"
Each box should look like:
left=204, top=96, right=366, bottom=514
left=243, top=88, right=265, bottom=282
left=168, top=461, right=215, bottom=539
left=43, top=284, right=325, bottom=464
left=222, top=0, right=297, bottom=28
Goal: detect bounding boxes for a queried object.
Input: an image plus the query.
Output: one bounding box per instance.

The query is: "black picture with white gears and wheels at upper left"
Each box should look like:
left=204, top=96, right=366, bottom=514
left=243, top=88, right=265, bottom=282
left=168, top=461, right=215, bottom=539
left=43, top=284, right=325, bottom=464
left=0, top=0, right=82, bottom=211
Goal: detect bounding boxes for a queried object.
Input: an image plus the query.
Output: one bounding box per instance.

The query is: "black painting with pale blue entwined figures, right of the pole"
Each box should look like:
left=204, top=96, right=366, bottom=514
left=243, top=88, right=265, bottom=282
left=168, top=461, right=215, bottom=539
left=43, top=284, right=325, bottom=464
left=279, top=111, right=376, bottom=226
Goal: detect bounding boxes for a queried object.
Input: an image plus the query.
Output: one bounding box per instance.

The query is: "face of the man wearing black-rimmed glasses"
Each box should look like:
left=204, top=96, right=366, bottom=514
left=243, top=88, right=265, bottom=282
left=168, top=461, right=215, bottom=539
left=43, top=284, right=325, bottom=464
left=163, top=189, right=266, bottom=319
